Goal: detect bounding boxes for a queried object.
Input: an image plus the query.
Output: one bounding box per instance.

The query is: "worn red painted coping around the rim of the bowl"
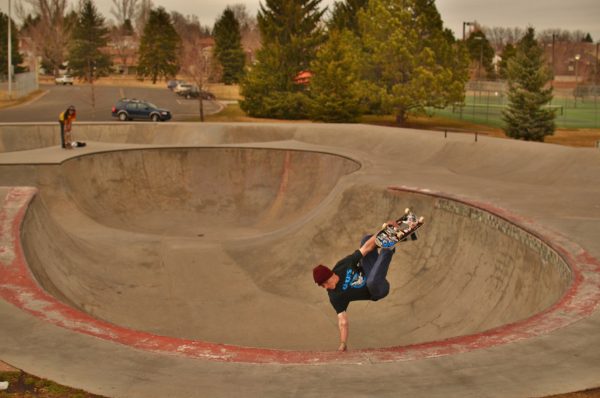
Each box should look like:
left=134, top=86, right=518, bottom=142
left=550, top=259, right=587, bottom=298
left=0, top=187, right=600, bottom=364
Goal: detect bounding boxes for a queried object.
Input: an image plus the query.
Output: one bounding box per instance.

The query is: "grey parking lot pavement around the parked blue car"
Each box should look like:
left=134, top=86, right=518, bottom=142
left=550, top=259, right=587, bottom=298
left=0, top=84, right=220, bottom=122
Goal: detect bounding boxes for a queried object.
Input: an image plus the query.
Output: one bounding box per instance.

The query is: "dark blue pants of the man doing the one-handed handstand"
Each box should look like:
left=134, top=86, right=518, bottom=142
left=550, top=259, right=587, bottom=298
left=360, top=235, right=396, bottom=301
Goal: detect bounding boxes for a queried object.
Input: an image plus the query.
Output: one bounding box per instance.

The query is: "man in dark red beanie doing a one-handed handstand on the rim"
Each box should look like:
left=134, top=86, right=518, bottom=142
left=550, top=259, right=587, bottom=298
left=313, top=221, right=398, bottom=351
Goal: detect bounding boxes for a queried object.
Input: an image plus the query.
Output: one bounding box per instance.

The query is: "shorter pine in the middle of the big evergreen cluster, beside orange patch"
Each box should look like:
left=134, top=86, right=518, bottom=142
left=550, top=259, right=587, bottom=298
left=310, top=30, right=361, bottom=123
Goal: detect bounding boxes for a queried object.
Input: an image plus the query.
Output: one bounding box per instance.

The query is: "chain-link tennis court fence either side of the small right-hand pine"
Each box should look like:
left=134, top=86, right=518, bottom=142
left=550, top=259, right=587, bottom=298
left=434, top=81, right=600, bottom=128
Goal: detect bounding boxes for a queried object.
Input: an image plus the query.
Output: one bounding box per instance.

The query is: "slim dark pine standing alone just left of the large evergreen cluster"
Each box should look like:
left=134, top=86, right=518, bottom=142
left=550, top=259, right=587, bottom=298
left=213, top=7, right=246, bottom=84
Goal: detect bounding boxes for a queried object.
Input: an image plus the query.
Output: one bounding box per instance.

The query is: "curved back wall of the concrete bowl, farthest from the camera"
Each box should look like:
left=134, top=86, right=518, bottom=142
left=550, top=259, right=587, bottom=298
left=43, top=148, right=359, bottom=236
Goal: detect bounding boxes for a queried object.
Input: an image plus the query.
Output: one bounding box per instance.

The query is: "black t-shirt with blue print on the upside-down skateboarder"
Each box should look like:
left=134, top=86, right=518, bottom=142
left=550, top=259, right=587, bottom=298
left=327, top=250, right=371, bottom=314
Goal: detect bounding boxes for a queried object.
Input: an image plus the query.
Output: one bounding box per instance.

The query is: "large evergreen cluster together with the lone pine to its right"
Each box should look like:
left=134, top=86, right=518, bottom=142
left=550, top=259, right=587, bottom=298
left=240, top=0, right=568, bottom=141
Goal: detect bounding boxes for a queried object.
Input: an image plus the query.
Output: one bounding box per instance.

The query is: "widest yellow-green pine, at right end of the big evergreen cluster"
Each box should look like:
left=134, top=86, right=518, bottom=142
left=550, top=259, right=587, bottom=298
left=359, top=0, right=468, bottom=124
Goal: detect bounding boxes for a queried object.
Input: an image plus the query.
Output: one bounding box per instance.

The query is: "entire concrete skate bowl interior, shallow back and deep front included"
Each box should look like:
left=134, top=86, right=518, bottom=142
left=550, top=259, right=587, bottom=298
left=3, top=148, right=573, bottom=362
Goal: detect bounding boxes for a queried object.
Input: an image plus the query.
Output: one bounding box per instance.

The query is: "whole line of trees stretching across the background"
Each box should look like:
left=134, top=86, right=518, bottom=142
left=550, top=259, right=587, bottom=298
left=2, top=0, right=572, bottom=140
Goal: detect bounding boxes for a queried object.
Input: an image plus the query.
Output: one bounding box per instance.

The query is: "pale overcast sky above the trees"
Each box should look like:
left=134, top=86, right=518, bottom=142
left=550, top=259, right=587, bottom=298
left=0, top=0, right=600, bottom=42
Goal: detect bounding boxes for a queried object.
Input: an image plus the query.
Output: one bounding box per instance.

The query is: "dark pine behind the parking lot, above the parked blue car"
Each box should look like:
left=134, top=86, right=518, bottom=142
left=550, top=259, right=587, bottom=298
left=138, top=7, right=181, bottom=84
